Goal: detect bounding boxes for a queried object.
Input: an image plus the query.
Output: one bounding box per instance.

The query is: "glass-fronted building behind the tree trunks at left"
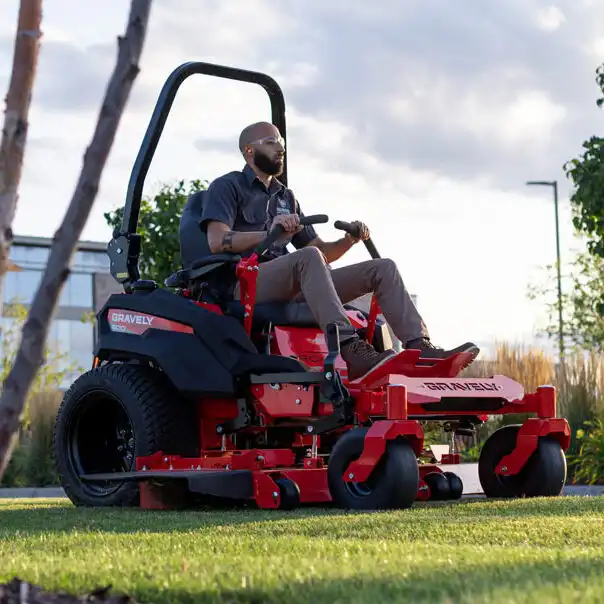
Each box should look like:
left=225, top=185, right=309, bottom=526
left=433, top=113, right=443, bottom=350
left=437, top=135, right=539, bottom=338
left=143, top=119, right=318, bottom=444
left=2, top=236, right=122, bottom=388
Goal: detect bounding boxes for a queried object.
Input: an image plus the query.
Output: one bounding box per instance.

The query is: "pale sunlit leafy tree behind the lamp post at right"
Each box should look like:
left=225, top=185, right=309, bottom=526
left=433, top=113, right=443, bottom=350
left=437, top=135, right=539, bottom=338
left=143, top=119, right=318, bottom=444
left=529, top=252, right=604, bottom=352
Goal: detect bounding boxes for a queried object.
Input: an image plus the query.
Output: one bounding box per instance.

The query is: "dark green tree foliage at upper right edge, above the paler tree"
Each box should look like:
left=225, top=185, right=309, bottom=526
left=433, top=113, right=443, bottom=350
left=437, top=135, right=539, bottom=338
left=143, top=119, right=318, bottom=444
left=564, top=64, right=604, bottom=258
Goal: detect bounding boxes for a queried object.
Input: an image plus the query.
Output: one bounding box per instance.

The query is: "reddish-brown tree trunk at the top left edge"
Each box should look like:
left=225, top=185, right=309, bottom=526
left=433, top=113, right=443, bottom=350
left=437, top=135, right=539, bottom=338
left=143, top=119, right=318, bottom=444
left=0, top=0, right=42, bottom=317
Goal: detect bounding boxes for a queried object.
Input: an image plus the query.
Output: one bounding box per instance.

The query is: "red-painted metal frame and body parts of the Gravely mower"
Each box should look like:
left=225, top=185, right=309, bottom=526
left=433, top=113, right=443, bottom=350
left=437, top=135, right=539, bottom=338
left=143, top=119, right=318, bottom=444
left=136, top=254, right=570, bottom=508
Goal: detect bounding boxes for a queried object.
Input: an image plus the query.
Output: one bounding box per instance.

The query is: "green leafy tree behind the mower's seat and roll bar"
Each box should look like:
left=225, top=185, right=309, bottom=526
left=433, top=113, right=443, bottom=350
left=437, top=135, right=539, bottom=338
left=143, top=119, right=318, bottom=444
left=104, top=180, right=208, bottom=286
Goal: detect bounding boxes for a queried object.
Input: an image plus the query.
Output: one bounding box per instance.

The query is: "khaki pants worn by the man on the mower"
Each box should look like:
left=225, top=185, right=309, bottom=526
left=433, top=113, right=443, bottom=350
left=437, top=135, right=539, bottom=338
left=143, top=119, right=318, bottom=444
left=235, top=247, right=428, bottom=346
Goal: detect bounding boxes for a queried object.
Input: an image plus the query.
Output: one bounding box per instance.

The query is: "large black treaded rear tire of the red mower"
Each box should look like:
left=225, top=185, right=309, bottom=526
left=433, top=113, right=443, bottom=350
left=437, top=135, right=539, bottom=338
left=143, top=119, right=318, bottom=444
left=53, top=364, right=198, bottom=506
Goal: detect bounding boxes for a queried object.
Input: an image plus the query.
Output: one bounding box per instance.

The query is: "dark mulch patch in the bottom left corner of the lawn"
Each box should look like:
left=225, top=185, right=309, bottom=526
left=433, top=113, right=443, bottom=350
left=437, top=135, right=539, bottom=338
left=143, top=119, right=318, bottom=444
left=0, top=577, right=137, bottom=604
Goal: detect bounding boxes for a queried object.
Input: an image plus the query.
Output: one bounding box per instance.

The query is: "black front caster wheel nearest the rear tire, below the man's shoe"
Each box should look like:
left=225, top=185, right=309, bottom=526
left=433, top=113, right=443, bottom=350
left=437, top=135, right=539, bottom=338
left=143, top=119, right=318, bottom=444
left=327, top=428, right=419, bottom=510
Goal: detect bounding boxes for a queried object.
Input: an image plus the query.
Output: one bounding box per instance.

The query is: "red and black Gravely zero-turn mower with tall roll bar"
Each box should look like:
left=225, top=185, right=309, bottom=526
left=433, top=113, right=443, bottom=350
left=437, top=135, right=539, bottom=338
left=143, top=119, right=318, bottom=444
left=54, top=62, right=570, bottom=509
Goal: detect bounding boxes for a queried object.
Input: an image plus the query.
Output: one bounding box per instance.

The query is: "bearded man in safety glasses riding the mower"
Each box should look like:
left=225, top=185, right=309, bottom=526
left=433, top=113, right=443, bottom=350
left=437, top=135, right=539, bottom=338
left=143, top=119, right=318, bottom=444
left=198, top=122, right=478, bottom=379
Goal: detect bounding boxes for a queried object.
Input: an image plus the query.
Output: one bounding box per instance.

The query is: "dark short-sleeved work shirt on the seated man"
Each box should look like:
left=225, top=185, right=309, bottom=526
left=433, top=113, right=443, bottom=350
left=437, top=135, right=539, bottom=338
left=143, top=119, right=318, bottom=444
left=201, top=165, right=317, bottom=257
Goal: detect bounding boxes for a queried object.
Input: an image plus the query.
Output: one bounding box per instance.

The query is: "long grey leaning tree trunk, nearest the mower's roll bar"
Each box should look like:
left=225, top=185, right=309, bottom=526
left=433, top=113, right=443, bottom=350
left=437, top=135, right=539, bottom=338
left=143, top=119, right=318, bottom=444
left=0, top=0, right=151, bottom=480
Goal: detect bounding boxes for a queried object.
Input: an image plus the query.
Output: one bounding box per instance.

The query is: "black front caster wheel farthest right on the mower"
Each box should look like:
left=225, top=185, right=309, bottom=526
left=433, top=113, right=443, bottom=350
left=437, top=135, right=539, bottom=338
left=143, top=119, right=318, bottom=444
left=478, top=425, right=567, bottom=498
